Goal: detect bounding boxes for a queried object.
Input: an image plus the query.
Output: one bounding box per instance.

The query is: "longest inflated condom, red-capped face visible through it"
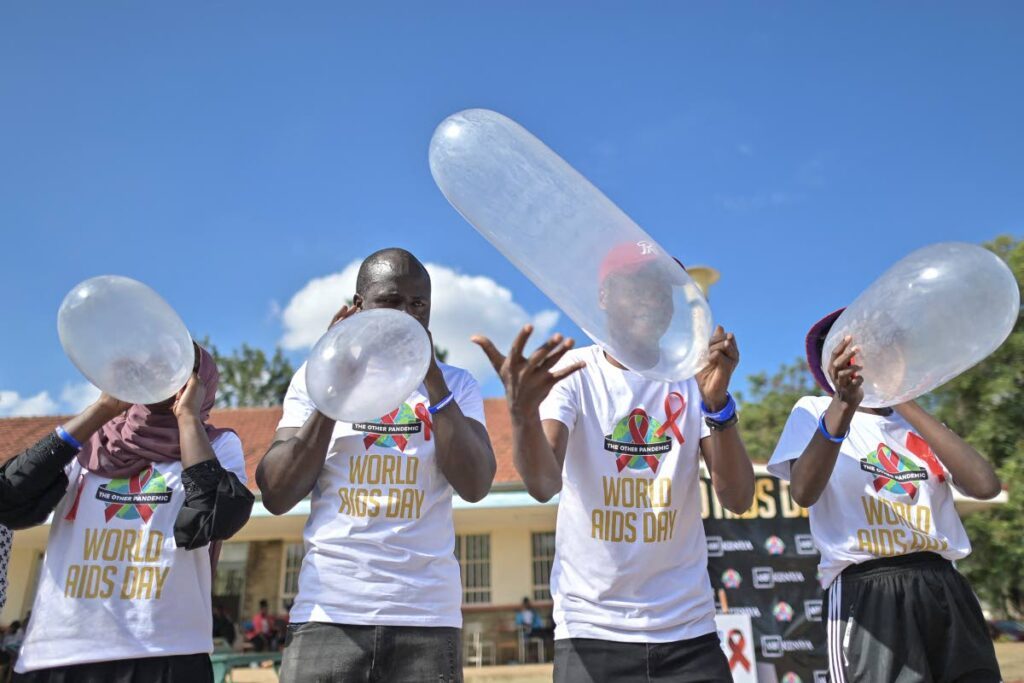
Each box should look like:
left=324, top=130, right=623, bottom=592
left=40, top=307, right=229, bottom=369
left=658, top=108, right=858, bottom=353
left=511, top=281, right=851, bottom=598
left=430, top=110, right=712, bottom=381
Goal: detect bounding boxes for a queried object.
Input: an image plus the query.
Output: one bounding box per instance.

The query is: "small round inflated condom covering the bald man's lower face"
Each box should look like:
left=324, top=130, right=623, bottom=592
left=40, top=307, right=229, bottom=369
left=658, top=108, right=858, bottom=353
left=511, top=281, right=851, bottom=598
left=306, top=308, right=433, bottom=422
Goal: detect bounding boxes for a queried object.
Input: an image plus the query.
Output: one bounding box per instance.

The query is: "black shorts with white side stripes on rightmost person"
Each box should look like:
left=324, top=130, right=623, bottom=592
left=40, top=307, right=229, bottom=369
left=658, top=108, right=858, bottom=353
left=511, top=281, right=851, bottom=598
left=824, top=553, right=1001, bottom=683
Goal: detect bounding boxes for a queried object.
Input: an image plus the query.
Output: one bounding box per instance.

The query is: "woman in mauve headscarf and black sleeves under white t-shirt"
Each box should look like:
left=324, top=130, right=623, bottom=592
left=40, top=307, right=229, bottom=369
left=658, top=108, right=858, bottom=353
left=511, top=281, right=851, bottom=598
left=0, top=345, right=254, bottom=683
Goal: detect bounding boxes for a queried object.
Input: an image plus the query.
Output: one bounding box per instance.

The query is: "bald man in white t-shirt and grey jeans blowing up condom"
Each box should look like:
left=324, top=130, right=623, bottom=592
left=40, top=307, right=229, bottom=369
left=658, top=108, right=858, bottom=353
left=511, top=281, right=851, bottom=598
left=256, top=249, right=496, bottom=683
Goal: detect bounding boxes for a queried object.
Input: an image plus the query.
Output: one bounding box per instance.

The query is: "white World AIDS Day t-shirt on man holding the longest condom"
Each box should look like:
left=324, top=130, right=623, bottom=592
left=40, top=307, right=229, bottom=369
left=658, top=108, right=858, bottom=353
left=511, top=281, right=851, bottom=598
left=541, top=346, right=715, bottom=642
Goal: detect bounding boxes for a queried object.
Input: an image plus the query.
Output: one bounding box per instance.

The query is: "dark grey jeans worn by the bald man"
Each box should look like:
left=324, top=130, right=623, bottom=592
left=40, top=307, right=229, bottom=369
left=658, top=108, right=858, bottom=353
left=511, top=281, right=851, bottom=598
left=281, top=622, right=462, bottom=683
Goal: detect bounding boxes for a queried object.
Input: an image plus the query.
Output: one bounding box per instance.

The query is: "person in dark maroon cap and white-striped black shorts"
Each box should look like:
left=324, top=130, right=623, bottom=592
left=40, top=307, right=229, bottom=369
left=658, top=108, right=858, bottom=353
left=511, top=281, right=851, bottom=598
left=768, top=310, right=1001, bottom=683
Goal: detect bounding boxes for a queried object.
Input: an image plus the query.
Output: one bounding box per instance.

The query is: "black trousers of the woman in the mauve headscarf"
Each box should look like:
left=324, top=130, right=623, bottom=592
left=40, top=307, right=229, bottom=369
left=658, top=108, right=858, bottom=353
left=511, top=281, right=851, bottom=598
left=13, top=652, right=213, bottom=683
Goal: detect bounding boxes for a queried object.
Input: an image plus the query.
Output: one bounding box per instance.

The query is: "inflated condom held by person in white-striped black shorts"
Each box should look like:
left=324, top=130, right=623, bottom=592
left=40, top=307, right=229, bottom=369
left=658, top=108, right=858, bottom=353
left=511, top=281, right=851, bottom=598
left=821, top=242, right=1020, bottom=408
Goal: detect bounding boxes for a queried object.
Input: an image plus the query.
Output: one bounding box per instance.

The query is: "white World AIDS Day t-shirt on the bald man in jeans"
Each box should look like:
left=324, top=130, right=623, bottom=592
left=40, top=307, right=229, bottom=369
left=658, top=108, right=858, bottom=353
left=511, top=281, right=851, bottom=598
left=278, top=364, right=484, bottom=628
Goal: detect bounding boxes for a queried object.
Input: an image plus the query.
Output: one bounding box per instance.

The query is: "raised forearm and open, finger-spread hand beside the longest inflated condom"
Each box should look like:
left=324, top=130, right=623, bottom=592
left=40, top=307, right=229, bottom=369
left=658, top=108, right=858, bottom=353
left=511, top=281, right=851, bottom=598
left=473, top=325, right=585, bottom=503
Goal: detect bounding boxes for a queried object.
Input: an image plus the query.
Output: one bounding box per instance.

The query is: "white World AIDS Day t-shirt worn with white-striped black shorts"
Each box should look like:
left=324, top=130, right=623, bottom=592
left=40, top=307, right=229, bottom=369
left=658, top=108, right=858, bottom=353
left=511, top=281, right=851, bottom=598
left=768, top=396, right=971, bottom=588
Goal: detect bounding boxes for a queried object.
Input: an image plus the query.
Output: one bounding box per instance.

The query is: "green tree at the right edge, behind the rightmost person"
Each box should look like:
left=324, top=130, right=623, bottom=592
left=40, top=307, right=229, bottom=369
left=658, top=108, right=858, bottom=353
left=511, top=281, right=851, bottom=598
left=926, top=237, right=1024, bottom=614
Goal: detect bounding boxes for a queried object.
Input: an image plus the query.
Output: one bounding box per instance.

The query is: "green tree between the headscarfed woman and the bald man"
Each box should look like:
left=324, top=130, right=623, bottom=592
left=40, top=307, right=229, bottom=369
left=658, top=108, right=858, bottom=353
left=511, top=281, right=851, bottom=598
left=200, top=340, right=295, bottom=408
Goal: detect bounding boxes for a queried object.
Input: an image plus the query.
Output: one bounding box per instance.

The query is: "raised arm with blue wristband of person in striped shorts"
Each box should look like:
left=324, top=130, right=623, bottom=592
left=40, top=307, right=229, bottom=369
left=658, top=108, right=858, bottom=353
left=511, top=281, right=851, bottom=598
left=790, top=336, right=864, bottom=508
